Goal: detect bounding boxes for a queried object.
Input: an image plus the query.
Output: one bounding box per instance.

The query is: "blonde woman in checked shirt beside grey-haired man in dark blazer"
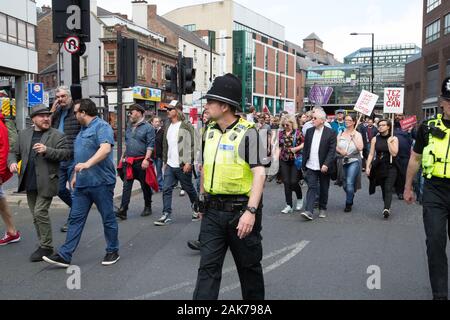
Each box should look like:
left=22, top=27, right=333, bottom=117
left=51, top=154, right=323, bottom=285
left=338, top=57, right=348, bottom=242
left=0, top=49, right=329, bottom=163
left=279, top=115, right=303, bottom=214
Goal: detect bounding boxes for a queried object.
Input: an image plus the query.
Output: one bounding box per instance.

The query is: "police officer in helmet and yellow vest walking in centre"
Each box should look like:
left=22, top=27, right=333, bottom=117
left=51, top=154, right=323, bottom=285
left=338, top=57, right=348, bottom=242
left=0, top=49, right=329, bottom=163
left=193, top=74, right=267, bottom=300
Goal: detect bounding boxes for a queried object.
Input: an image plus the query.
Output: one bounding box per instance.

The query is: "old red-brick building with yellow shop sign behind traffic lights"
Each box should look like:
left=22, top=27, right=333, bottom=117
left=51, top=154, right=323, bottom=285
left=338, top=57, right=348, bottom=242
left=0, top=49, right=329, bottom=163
left=58, top=0, right=177, bottom=116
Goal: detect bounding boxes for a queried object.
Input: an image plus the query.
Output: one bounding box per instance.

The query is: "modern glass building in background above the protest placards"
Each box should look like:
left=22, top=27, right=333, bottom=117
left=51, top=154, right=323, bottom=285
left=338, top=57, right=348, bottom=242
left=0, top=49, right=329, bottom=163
left=306, top=44, right=421, bottom=114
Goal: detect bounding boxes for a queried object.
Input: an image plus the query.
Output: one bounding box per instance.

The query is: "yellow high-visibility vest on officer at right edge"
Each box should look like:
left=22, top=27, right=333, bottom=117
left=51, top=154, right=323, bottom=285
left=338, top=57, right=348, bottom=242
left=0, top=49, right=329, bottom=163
left=422, top=114, right=450, bottom=179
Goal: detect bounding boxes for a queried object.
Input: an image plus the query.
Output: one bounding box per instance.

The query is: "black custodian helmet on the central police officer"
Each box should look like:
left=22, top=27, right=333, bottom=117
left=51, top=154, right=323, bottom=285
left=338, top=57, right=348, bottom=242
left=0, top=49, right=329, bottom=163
left=202, top=73, right=242, bottom=111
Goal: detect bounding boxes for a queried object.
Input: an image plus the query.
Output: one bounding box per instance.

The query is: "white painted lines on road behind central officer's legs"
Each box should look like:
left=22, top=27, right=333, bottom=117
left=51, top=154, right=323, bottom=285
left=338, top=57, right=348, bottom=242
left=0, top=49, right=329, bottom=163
left=131, top=240, right=309, bottom=300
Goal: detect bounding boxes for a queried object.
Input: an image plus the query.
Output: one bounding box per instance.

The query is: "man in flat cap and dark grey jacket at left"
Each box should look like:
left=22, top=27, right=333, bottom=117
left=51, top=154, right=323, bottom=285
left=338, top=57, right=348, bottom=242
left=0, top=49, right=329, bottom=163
left=9, top=105, right=72, bottom=262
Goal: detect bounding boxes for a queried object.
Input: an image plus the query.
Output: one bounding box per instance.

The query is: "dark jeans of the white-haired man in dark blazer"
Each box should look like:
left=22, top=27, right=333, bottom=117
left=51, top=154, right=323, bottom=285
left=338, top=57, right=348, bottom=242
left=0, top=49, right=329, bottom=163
left=305, top=169, right=331, bottom=214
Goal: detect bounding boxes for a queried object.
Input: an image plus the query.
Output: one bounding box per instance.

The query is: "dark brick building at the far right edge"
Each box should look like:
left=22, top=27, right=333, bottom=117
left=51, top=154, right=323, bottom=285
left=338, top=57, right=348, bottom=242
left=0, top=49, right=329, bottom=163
left=405, top=0, right=450, bottom=119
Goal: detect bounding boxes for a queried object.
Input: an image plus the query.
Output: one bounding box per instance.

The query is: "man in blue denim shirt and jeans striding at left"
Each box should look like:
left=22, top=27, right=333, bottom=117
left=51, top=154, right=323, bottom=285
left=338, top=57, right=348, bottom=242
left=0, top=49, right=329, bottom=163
left=43, top=99, right=120, bottom=268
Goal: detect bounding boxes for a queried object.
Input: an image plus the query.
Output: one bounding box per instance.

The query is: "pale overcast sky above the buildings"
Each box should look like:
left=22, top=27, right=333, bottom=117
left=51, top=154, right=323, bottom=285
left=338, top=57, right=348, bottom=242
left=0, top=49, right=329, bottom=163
left=36, top=0, right=423, bottom=62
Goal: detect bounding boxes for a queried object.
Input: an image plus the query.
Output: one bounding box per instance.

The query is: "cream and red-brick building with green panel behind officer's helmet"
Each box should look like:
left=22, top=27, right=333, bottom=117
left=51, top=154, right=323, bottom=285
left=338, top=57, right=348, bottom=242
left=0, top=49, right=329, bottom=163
left=164, top=0, right=296, bottom=113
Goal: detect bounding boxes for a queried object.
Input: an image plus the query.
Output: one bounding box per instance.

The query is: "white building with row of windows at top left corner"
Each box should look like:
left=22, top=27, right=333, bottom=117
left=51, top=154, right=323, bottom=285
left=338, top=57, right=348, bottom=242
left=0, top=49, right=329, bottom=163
left=0, top=0, right=38, bottom=129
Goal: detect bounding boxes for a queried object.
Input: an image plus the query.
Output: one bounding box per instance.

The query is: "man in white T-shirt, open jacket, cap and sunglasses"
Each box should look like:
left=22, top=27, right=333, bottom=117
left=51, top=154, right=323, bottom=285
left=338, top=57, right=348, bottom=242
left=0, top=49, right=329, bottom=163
left=154, top=101, right=200, bottom=226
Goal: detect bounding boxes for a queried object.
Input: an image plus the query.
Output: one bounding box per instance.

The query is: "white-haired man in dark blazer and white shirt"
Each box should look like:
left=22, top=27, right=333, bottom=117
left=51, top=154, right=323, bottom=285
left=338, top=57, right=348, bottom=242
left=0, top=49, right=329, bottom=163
left=302, top=110, right=337, bottom=220
